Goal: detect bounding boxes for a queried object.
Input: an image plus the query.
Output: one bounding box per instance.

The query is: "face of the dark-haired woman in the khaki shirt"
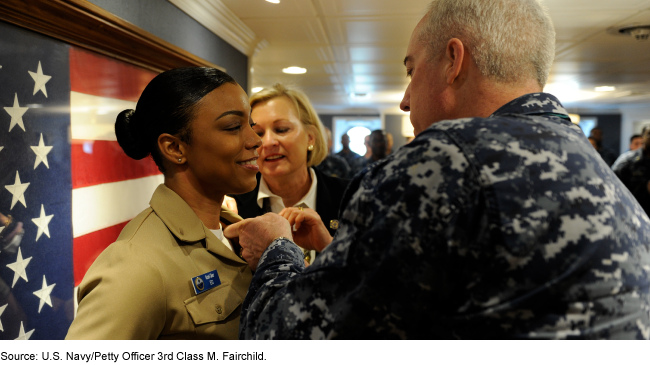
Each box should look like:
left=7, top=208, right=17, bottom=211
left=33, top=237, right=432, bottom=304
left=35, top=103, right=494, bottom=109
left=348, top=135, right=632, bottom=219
left=185, top=83, right=261, bottom=194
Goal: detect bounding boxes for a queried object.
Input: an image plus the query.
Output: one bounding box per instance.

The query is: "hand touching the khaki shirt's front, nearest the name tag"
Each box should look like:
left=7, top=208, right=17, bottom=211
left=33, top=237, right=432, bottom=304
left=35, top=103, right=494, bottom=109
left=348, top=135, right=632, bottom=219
left=223, top=213, right=293, bottom=270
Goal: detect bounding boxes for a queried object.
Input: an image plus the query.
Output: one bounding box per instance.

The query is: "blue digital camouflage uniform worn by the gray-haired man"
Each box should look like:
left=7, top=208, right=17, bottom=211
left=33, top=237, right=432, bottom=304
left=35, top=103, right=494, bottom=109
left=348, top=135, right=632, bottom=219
left=240, top=93, right=650, bottom=339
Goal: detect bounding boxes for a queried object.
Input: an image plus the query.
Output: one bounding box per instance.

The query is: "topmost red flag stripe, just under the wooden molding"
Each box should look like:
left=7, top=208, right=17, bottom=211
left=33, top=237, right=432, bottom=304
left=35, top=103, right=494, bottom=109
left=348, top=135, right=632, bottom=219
left=70, top=47, right=157, bottom=101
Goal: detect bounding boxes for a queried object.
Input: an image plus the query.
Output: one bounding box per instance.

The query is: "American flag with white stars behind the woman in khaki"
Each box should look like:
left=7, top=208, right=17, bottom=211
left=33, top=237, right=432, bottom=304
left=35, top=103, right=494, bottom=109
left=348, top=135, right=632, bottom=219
left=0, top=22, right=162, bottom=340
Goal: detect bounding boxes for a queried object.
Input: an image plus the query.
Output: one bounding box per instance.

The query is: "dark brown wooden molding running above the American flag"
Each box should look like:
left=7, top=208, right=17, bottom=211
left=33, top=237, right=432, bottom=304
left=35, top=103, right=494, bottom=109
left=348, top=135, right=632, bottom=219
left=0, top=0, right=225, bottom=72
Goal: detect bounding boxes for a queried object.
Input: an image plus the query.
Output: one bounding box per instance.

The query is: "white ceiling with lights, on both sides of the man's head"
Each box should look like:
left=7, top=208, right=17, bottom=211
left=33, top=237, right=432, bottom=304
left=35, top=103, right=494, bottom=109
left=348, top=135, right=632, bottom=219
left=216, top=0, right=650, bottom=113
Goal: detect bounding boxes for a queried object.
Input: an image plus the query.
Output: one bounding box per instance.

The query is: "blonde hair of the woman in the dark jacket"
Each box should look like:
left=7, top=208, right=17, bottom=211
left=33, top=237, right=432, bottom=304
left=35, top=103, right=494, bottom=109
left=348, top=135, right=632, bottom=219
left=250, top=84, right=328, bottom=166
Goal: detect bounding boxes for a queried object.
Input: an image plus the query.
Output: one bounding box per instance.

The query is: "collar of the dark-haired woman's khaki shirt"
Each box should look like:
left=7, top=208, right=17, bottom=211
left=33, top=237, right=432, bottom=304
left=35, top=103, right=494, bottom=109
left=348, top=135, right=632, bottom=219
left=149, top=184, right=245, bottom=264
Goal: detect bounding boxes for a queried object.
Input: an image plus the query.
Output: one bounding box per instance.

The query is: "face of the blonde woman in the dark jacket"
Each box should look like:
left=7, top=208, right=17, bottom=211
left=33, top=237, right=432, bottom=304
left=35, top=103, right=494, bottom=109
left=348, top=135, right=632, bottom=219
left=251, top=97, right=314, bottom=179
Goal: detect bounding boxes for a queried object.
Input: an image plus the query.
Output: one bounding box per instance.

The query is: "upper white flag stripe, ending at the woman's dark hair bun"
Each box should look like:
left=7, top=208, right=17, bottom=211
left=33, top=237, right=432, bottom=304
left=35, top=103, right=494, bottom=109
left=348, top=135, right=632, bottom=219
left=70, top=91, right=135, bottom=141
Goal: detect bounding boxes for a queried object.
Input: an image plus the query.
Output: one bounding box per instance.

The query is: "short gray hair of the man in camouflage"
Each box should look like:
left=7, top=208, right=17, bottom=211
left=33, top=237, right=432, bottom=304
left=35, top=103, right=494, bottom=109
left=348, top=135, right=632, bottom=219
left=420, top=0, right=555, bottom=87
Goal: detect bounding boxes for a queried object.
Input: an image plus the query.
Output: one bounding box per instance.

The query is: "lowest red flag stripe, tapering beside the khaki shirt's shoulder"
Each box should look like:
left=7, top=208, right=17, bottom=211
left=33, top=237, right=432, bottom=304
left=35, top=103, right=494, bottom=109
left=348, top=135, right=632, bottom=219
left=72, top=222, right=128, bottom=286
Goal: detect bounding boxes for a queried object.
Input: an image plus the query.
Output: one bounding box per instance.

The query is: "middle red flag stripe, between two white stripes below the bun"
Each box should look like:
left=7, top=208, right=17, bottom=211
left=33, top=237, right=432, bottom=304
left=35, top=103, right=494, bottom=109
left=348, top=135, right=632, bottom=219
left=71, top=140, right=160, bottom=189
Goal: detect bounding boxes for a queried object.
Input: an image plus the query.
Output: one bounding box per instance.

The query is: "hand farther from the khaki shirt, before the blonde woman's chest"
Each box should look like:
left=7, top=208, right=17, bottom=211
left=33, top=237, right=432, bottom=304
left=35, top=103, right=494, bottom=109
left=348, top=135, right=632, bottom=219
left=280, top=207, right=332, bottom=252
